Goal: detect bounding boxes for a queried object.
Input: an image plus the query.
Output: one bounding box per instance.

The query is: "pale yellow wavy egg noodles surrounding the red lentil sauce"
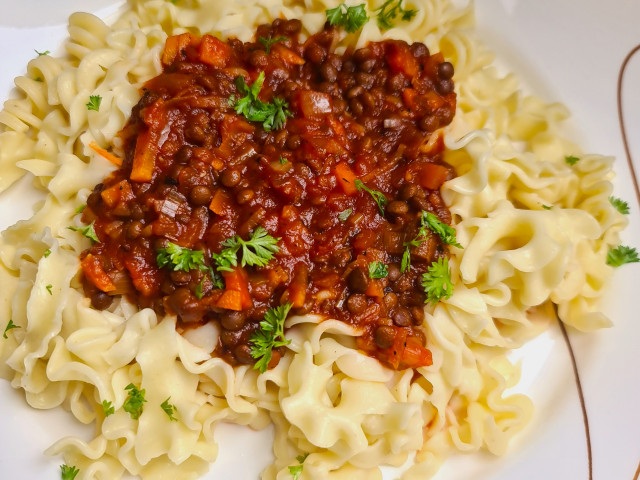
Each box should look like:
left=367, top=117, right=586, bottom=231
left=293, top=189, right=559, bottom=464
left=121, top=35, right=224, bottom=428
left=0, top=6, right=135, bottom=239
left=0, top=0, right=625, bottom=480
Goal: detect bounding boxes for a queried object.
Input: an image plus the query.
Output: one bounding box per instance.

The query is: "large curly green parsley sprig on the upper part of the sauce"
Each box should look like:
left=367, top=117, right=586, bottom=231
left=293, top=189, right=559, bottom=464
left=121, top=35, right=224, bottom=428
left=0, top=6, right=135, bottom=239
left=229, top=72, right=293, bottom=132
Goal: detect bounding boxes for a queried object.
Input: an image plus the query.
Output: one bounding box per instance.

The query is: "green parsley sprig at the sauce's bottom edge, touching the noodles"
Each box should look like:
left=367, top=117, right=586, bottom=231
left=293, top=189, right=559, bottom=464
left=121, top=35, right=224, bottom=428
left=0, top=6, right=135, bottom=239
left=249, top=303, right=293, bottom=373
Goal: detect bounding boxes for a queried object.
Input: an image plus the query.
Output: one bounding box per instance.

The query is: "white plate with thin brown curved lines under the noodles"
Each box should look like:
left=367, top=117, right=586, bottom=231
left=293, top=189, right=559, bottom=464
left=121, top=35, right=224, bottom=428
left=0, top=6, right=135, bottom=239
left=0, top=0, right=640, bottom=480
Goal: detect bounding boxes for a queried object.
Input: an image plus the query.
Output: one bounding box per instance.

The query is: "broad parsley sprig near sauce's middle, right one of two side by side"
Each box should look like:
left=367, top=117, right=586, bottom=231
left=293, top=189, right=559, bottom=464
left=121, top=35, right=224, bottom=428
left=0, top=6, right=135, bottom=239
left=212, top=227, right=280, bottom=271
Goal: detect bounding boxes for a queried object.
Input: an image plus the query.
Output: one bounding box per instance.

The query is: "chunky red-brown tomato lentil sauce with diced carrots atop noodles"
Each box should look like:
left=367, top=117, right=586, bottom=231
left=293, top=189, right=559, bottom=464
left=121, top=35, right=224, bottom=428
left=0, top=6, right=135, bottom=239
left=82, top=19, right=456, bottom=368
